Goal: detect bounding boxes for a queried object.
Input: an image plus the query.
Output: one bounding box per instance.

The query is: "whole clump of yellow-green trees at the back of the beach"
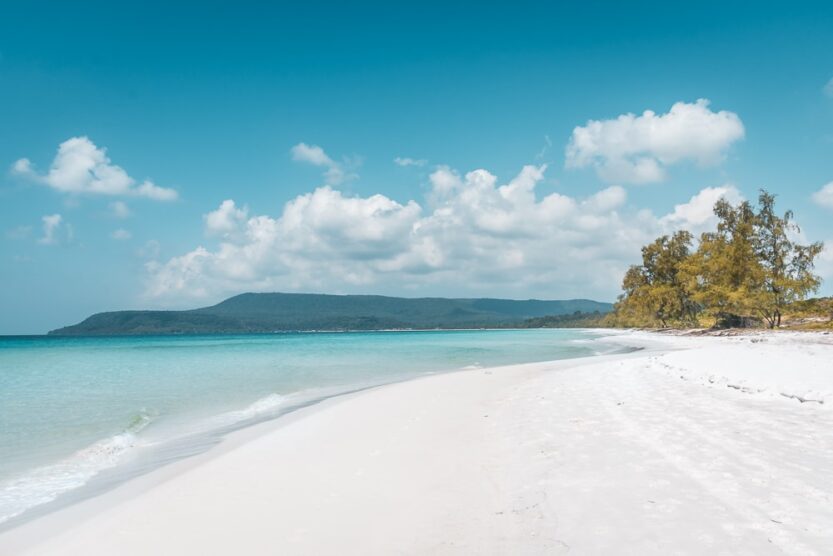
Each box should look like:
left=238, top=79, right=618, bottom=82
left=611, top=191, right=823, bottom=328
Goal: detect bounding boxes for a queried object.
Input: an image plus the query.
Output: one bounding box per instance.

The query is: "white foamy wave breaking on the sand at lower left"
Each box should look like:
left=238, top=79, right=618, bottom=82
left=0, top=409, right=159, bottom=523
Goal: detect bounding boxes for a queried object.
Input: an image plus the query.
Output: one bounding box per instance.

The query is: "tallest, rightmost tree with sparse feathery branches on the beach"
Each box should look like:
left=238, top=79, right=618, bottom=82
left=754, top=190, right=823, bottom=328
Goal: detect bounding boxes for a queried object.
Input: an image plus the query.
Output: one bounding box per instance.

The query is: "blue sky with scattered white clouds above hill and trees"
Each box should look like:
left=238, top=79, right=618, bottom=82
left=0, top=1, right=833, bottom=334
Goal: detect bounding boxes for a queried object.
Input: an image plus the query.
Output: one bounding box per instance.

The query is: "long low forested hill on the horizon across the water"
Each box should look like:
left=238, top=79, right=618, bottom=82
left=49, top=293, right=613, bottom=336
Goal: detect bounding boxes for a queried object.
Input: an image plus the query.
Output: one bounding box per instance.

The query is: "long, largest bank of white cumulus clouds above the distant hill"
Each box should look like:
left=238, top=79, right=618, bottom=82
left=141, top=165, right=737, bottom=305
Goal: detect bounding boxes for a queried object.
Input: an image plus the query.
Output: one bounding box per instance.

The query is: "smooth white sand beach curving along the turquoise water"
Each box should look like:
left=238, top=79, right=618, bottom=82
left=0, top=332, right=833, bottom=556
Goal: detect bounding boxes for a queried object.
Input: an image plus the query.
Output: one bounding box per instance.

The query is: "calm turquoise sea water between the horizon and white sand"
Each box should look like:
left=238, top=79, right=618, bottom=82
left=0, top=330, right=616, bottom=523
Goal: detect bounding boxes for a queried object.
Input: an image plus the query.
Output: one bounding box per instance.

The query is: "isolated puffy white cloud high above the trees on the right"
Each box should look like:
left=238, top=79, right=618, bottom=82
left=566, top=99, right=745, bottom=183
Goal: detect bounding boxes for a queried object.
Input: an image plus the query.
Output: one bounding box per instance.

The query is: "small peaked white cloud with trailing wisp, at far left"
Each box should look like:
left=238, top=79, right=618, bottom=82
left=12, top=137, right=177, bottom=201
